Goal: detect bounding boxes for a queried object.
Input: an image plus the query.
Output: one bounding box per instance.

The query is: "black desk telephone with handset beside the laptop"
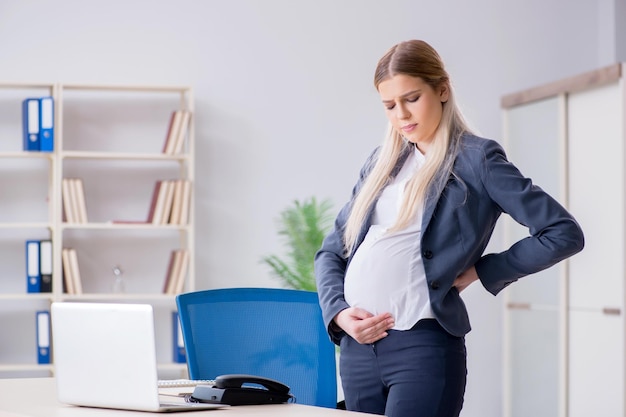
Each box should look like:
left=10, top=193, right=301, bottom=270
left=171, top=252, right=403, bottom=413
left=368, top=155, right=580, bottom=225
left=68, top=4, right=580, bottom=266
left=190, top=374, right=294, bottom=405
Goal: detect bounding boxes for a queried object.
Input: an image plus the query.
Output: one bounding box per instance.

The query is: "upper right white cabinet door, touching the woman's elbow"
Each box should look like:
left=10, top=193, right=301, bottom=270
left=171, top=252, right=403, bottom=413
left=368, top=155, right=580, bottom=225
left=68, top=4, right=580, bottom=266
left=568, top=83, right=625, bottom=309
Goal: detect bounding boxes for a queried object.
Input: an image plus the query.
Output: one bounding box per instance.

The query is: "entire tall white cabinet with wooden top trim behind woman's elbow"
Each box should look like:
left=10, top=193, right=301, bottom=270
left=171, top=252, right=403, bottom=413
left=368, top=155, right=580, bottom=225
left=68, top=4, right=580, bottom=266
left=502, top=64, right=626, bottom=417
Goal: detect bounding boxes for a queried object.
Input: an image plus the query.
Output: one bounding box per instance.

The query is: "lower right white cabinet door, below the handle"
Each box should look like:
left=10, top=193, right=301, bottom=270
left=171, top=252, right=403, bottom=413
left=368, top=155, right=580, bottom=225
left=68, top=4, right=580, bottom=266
left=568, top=310, right=624, bottom=417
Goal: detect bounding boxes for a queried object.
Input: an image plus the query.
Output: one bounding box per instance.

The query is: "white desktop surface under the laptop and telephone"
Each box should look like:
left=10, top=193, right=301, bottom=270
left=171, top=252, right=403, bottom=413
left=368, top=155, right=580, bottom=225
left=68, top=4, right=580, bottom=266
left=0, top=378, right=371, bottom=417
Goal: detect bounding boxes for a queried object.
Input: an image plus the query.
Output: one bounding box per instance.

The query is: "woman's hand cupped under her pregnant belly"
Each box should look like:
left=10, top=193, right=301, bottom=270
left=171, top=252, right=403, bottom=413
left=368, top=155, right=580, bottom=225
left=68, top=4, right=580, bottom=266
left=334, top=307, right=395, bottom=344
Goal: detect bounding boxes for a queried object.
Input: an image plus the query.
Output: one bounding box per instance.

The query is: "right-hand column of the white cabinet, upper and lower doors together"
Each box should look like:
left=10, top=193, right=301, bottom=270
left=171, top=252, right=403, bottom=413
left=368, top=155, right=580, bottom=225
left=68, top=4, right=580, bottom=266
left=568, top=78, right=626, bottom=417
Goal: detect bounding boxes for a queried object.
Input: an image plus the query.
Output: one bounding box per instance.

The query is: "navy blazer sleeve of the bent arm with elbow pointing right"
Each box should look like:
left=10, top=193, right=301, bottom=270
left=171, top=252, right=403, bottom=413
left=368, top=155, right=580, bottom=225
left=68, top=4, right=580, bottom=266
left=475, top=141, right=584, bottom=295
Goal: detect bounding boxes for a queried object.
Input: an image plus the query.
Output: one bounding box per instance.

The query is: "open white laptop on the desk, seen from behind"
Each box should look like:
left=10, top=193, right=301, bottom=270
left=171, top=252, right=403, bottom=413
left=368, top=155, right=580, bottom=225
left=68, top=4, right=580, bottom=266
left=51, top=302, right=228, bottom=412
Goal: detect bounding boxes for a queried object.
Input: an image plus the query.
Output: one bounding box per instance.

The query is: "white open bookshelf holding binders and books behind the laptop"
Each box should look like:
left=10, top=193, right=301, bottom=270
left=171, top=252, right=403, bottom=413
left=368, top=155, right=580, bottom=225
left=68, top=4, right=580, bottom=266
left=0, top=83, right=195, bottom=378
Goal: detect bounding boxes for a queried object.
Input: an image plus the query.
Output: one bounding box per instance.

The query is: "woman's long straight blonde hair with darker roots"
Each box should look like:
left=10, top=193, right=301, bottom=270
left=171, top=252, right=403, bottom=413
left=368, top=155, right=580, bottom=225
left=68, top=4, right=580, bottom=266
left=343, top=40, right=470, bottom=255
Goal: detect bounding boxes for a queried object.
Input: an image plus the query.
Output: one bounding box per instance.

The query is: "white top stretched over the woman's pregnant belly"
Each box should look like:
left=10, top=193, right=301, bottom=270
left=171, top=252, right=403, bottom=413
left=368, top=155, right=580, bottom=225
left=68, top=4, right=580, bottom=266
left=344, top=149, right=434, bottom=330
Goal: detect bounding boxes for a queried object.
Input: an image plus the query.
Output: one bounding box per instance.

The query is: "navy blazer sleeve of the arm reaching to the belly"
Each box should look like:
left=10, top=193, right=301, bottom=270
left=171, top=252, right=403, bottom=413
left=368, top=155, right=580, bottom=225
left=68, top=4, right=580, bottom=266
left=314, top=148, right=379, bottom=344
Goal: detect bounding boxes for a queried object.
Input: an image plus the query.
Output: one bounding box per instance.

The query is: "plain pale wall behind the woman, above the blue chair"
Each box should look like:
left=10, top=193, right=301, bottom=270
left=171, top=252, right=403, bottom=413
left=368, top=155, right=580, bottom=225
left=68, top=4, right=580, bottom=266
left=0, top=0, right=604, bottom=417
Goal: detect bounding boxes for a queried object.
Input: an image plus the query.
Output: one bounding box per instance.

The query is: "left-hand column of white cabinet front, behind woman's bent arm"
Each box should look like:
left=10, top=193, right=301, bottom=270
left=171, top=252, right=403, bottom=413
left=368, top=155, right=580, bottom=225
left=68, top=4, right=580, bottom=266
left=503, top=97, right=565, bottom=417
